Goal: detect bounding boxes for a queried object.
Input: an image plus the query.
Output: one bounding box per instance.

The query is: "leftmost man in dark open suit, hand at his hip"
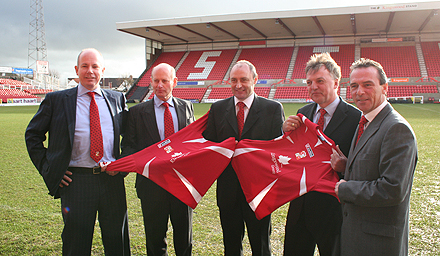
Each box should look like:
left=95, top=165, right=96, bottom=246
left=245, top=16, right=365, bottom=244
left=25, top=49, right=130, bottom=255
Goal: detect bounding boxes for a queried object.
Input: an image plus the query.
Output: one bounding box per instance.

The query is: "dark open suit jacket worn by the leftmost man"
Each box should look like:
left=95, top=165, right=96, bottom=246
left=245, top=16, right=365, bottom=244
left=25, top=87, right=127, bottom=198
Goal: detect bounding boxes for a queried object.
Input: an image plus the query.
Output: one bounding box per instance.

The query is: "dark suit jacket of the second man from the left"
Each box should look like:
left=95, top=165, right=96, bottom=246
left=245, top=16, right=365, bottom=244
left=122, top=97, right=195, bottom=201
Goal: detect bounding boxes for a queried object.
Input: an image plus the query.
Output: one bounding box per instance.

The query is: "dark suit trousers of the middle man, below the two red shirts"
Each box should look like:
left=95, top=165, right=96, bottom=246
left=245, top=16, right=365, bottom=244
left=219, top=188, right=272, bottom=256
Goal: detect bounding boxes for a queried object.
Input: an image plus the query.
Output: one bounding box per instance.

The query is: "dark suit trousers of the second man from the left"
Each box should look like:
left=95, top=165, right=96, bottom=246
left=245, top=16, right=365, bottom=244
left=141, top=184, right=193, bottom=256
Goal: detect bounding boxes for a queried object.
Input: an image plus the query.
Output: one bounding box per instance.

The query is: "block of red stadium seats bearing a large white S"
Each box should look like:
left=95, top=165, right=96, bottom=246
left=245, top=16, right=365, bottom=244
left=177, top=50, right=237, bottom=81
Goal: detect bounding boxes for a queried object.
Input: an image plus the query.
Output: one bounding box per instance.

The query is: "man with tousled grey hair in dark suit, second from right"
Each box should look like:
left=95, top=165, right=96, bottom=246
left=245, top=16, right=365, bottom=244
left=283, top=53, right=361, bottom=256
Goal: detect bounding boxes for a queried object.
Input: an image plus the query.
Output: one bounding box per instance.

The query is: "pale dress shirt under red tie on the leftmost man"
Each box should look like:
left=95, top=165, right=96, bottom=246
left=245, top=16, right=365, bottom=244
left=66, top=84, right=116, bottom=168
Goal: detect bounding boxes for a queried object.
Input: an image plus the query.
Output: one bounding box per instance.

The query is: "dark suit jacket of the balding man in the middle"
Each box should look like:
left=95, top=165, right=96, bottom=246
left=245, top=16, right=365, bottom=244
left=203, top=95, right=284, bottom=207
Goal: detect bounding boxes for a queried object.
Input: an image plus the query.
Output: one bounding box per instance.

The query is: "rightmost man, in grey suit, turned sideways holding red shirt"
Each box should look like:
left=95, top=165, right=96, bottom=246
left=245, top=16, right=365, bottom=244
left=332, top=59, right=417, bottom=256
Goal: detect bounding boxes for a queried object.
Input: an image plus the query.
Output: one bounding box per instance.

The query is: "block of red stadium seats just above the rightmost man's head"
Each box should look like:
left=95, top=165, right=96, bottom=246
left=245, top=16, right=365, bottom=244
left=361, top=46, right=421, bottom=77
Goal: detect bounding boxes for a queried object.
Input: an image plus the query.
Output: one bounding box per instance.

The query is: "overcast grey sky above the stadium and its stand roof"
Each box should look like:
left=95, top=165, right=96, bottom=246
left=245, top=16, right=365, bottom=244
left=0, top=0, right=430, bottom=84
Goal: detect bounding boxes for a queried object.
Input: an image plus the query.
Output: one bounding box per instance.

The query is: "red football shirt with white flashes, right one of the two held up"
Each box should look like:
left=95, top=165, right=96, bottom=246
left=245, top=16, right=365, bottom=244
left=232, top=114, right=339, bottom=219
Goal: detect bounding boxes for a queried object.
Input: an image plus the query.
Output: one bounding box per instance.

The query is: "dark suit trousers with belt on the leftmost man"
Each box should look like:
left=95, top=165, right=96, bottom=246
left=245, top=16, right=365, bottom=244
left=60, top=173, right=130, bottom=256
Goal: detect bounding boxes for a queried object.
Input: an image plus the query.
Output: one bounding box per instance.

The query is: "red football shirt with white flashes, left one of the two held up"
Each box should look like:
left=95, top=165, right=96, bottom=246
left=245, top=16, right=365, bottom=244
left=107, top=113, right=235, bottom=209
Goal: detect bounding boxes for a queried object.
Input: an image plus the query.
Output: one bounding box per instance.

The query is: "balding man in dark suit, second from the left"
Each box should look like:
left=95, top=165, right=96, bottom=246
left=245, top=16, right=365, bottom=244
left=122, top=63, right=194, bottom=256
